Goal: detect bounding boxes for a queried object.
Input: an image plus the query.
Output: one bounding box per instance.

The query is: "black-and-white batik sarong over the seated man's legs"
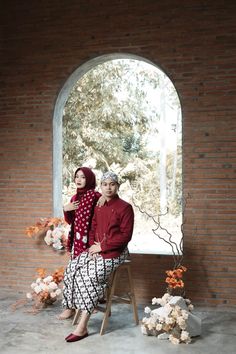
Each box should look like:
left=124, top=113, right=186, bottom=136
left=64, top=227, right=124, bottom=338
left=62, top=249, right=128, bottom=314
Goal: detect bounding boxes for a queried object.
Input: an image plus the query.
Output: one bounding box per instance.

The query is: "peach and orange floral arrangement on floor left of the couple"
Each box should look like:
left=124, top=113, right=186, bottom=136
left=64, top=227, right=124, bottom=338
left=26, top=268, right=64, bottom=309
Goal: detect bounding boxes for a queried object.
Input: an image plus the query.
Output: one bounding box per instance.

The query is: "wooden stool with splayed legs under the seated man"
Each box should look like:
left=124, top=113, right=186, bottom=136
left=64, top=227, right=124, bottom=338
left=72, top=260, right=139, bottom=335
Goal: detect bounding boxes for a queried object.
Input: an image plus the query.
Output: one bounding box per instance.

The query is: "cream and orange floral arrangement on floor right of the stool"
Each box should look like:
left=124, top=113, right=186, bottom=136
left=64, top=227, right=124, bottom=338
left=141, top=265, right=201, bottom=344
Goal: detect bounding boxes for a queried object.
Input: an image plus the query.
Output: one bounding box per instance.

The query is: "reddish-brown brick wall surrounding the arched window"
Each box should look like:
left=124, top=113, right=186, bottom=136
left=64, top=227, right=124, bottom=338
left=0, top=0, right=236, bottom=306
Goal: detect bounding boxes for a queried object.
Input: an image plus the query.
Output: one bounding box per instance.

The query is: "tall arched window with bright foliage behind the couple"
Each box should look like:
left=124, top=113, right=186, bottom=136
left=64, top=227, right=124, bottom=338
left=53, top=54, right=182, bottom=254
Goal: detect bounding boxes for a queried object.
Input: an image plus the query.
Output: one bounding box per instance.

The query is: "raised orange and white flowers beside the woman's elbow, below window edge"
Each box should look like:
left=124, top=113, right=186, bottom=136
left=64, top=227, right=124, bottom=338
left=25, top=218, right=70, bottom=251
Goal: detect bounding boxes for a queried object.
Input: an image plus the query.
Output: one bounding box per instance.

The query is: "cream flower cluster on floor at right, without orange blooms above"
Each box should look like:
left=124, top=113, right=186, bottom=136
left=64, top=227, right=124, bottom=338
left=141, top=293, right=196, bottom=344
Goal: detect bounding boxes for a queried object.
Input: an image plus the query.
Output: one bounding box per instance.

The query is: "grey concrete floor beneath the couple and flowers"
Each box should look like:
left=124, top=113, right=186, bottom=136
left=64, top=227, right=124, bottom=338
left=0, top=292, right=236, bottom=354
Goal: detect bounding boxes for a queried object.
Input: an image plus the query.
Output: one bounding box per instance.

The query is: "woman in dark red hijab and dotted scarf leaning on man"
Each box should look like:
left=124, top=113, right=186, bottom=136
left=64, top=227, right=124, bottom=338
left=59, top=167, right=101, bottom=320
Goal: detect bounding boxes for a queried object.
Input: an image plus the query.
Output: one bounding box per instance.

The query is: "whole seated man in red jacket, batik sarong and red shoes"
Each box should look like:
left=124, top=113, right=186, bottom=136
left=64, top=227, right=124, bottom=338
left=63, top=172, right=134, bottom=342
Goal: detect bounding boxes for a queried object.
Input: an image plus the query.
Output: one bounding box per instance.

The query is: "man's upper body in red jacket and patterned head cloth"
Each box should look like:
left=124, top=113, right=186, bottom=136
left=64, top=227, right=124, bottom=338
left=89, top=172, right=134, bottom=258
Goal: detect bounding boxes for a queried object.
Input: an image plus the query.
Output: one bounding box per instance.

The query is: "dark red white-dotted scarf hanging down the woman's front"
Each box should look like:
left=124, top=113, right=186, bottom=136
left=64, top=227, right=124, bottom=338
left=72, top=189, right=96, bottom=258
